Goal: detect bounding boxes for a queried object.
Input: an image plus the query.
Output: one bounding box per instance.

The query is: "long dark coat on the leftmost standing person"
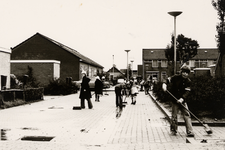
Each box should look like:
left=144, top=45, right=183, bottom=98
left=79, top=76, right=91, bottom=99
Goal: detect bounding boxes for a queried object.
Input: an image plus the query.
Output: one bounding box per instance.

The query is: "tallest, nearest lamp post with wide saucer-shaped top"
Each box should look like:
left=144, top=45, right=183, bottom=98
left=168, top=11, right=182, bottom=74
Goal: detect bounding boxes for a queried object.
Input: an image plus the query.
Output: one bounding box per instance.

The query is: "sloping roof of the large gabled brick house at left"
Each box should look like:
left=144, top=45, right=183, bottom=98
left=13, top=33, right=104, bottom=68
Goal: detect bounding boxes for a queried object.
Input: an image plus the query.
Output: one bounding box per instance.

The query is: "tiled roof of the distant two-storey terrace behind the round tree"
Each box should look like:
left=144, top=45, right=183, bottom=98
left=143, top=48, right=219, bottom=60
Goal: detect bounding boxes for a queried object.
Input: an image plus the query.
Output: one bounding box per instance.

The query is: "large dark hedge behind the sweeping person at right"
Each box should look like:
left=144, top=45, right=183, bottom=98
left=153, top=76, right=225, bottom=118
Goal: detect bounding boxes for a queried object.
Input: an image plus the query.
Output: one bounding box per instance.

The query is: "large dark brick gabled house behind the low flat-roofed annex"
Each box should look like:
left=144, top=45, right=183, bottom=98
left=11, top=33, right=104, bottom=85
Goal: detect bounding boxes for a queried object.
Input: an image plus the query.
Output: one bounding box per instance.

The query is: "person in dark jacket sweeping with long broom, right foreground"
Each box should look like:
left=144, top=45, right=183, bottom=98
left=162, top=66, right=194, bottom=137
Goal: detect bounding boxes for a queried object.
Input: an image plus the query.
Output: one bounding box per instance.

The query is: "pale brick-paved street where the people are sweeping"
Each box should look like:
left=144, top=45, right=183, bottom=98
left=0, top=91, right=224, bottom=150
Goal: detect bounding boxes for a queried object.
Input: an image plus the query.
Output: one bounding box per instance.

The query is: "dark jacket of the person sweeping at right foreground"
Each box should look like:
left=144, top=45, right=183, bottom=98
left=167, top=75, right=191, bottom=101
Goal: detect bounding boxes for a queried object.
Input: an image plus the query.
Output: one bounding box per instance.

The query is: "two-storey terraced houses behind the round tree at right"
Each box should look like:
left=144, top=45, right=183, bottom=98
left=142, top=48, right=218, bottom=81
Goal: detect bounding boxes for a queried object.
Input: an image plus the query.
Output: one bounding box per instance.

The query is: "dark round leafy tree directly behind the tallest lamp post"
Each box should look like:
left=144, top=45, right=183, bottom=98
left=165, top=34, right=199, bottom=63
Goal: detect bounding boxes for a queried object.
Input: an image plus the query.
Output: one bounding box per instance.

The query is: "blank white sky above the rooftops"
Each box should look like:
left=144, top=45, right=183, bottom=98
left=0, top=0, right=219, bottom=71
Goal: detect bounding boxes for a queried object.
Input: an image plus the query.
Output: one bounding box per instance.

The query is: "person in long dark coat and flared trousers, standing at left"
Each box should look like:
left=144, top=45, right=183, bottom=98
left=79, top=71, right=93, bottom=109
